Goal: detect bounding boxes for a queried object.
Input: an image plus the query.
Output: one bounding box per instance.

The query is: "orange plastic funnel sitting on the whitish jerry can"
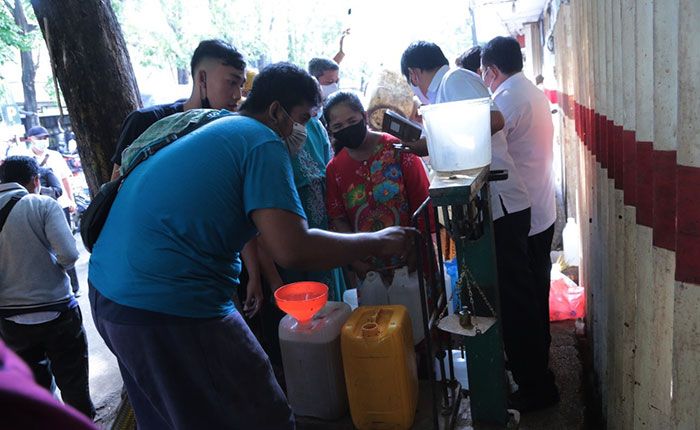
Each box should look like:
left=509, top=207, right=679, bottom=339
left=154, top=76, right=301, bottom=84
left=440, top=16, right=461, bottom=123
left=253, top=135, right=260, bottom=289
left=275, top=282, right=328, bottom=323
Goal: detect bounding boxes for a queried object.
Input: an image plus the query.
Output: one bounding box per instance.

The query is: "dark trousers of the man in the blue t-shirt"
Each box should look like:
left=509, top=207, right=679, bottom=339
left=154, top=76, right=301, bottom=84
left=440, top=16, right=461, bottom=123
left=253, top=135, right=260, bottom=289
left=89, top=287, right=294, bottom=430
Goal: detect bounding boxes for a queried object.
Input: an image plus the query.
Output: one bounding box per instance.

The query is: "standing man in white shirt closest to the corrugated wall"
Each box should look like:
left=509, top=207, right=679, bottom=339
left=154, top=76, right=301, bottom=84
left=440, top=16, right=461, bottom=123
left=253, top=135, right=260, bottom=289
left=481, top=37, right=559, bottom=410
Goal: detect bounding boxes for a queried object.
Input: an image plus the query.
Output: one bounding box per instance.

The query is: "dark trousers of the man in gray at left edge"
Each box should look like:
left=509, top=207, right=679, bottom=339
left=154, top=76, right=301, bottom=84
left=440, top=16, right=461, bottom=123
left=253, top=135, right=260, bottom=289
left=0, top=306, right=95, bottom=418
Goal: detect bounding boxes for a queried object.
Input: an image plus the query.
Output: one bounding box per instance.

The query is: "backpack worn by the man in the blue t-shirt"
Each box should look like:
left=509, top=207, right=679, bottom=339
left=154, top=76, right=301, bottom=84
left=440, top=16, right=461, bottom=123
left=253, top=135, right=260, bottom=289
left=80, top=109, right=234, bottom=252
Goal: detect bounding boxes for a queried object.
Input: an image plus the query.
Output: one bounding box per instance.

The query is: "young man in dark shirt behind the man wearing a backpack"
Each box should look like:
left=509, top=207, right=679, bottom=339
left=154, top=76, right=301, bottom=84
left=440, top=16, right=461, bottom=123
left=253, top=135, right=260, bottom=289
left=112, top=40, right=246, bottom=179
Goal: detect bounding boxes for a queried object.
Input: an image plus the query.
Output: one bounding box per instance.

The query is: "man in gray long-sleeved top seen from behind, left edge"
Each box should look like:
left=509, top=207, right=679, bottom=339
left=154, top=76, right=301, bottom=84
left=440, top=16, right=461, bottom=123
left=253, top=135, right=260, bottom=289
left=0, top=156, right=95, bottom=418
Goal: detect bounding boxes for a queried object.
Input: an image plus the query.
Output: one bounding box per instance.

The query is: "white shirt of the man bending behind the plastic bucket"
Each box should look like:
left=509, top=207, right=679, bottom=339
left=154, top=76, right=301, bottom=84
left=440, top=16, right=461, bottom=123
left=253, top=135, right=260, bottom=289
left=427, top=66, right=530, bottom=220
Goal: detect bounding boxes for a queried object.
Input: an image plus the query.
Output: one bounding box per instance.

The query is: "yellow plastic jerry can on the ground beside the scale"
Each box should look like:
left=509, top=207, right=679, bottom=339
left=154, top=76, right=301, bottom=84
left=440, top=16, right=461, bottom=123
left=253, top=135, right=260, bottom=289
left=341, top=305, right=418, bottom=430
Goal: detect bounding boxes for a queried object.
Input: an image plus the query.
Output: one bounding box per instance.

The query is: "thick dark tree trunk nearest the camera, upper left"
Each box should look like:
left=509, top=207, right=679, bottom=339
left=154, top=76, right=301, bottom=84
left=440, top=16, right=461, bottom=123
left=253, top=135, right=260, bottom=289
left=31, top=0, right=139, bottom=195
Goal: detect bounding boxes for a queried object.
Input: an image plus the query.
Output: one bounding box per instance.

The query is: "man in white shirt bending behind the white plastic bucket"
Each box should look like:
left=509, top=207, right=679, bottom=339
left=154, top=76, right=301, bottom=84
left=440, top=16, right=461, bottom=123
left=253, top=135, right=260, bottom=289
left=401, top=42, right=546, bottom=412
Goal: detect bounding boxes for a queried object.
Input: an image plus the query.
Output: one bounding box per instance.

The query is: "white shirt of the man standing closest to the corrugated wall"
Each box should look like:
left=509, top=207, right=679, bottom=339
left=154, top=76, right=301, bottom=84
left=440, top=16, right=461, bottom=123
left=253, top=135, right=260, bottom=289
left=493, top=73, right=557, bottom=236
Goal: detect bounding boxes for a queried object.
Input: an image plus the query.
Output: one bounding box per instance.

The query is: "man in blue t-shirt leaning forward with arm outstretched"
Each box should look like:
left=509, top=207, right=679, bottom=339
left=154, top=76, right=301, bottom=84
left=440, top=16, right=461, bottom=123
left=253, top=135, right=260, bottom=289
left=89, top=63, right=414, bottom=430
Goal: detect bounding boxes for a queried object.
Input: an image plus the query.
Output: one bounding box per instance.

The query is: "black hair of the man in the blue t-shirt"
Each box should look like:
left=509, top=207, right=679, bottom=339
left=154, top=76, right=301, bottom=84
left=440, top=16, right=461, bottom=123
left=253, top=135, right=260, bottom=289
left=241, top=63, right=321, bottom=113
